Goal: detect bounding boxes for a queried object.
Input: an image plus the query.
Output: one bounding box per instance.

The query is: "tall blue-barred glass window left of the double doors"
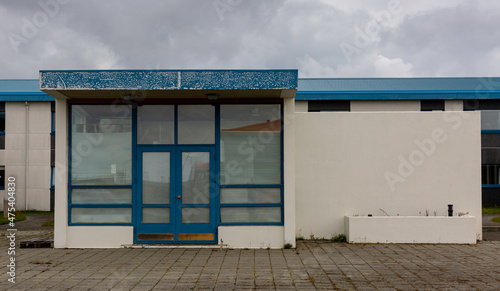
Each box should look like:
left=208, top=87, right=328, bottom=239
left=70, top=105, right=132, bottom=224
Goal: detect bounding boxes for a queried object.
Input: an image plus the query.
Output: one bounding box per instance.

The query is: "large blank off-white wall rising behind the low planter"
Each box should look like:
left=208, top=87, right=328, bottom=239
left=295, top=111, right=482, bottom=239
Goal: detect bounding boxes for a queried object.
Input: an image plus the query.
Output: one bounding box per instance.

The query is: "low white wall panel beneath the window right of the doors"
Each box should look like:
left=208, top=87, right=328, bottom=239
left=219, top=226, right=285, bottom=249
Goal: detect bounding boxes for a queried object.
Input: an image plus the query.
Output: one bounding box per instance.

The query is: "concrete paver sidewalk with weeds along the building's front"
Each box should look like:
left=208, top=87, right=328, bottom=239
left=0, top=230, right=500, bottom=290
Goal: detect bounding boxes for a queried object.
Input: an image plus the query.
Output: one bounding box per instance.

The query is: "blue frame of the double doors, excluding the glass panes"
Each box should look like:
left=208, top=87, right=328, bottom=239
left=133, top=145, right=218, bottom=244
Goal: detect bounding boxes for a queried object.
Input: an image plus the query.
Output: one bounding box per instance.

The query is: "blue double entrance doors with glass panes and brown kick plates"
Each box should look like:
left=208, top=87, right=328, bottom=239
left=134, top=146, right=217, bottom=243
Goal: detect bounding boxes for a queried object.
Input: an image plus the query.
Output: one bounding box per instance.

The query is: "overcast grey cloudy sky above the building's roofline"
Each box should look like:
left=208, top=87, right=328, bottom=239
left=0, top=0, right=500, bottom=79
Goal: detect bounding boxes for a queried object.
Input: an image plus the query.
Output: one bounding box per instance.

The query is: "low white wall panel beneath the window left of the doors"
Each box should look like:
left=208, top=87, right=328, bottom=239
left=66, top=226, right=134, bottom=248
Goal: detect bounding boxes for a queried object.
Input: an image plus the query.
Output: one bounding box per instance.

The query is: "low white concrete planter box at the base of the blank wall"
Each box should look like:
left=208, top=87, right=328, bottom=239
left=344, top=216, right=477, bottom=244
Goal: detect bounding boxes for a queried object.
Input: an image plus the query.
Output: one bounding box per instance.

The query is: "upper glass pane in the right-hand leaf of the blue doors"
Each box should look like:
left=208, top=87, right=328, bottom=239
left=182, top=152, right=210, bottom=204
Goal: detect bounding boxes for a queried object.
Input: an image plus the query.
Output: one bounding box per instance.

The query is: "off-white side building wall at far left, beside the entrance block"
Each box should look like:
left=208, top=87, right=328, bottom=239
left=0, top=102, right=51, bottom=211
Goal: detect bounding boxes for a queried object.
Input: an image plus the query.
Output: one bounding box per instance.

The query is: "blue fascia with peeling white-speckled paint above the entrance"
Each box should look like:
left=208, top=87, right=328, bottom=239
left=40, top=70, right=298, bottom=91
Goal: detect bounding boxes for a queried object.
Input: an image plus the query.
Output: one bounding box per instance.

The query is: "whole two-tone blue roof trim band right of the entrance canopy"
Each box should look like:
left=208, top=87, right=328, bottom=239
left=295, top=77, right=500, bottom=100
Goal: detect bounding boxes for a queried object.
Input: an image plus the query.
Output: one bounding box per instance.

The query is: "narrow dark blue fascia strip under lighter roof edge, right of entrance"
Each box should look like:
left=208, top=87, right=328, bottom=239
left=295, top=91, right=500, bottom=100
